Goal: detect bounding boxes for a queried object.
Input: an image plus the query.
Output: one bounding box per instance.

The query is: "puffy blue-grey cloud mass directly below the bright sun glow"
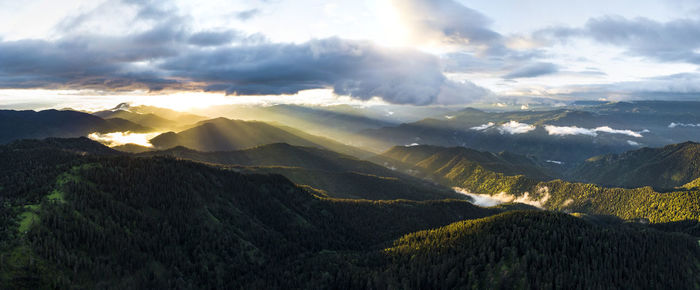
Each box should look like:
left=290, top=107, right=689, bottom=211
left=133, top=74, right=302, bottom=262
left=160, top=38, right=488, bottom=105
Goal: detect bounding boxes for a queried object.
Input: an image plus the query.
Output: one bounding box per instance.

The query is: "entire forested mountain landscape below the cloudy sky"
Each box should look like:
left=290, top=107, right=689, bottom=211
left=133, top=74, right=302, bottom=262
left=0, top=102, right=700, bottom=289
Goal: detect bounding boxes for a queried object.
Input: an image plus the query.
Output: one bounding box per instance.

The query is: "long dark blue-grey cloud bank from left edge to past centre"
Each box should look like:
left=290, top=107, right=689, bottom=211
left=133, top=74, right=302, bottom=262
left=0, top=1, right=491, bottom=105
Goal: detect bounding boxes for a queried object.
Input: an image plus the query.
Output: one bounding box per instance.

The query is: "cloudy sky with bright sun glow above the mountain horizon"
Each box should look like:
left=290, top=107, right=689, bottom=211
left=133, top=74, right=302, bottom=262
left=0, top=0, right=700, bottom=109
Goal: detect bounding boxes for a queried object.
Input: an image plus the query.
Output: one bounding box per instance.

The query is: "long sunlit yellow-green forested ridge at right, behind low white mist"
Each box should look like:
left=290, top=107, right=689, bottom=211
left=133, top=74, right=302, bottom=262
left=383, top=146, right=700, bottom=223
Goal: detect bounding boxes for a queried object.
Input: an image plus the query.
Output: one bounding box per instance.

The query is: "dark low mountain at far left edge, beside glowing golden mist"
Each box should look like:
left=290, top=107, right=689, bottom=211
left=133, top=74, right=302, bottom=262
left=0, top=110, right=152, bottom=144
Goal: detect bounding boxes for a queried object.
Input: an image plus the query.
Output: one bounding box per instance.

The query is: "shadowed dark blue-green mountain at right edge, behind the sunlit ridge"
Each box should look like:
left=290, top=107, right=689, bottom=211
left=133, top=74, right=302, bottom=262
left=568, top=142, right=700, bottom=190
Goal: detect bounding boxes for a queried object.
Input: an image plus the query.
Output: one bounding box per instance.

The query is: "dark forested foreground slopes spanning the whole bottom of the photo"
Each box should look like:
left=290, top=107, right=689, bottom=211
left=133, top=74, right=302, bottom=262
left=0, top=138, right=700, bottom=289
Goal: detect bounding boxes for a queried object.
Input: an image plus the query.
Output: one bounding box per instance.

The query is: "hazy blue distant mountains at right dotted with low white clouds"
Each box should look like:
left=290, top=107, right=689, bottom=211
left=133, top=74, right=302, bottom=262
left=360, top=102, right=700, bottom=164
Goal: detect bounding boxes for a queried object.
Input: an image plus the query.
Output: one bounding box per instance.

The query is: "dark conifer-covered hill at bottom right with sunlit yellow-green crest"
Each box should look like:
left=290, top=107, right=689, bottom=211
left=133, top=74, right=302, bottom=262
left=378, top=212, right=700, bottom=289
